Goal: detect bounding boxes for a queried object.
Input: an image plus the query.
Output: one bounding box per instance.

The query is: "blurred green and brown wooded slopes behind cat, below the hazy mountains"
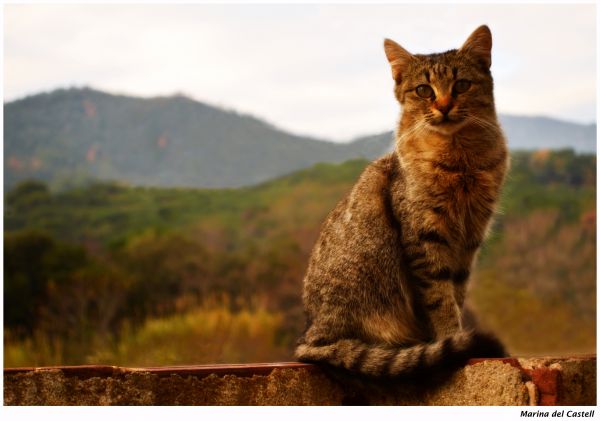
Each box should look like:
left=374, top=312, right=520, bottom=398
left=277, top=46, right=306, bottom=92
left=4, top=150, right=596, bottom=366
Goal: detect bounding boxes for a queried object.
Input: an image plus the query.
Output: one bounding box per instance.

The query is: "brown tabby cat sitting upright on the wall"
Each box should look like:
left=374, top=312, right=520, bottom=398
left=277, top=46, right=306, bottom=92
left=295, top=25, right=509, bottom=377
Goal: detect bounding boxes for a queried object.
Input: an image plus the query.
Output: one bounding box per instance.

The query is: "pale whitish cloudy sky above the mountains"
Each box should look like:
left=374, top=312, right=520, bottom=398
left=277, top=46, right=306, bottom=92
left=3, top=3, right=596, bottom=141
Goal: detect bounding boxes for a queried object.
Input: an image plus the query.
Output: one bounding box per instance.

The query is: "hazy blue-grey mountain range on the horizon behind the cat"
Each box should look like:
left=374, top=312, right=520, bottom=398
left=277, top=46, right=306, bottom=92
left=4, top=88, right=595, bottom=189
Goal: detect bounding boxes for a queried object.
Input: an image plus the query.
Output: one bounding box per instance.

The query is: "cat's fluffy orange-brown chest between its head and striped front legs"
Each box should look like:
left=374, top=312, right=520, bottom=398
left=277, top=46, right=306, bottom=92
left=400, top=131, right=506, bottom=249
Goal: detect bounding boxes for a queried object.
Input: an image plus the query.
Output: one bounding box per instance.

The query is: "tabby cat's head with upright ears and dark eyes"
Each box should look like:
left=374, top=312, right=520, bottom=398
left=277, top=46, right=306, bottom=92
left=384, top=25, right=495, bottom=134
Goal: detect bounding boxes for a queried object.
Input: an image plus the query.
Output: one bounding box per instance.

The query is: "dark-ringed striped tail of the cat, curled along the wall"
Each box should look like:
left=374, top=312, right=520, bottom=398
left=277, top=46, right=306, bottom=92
left=296, top=331, right=506, bottom=377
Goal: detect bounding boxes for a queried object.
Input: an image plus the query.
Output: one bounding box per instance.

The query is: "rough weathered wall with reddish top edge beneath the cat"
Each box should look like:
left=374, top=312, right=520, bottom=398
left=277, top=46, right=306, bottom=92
left=4, top=356, right=596, bottom=405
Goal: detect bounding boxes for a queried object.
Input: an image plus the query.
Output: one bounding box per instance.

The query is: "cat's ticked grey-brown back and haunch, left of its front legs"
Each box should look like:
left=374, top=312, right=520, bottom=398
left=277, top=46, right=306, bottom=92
left=303, top=154, right=419, bottom=343
